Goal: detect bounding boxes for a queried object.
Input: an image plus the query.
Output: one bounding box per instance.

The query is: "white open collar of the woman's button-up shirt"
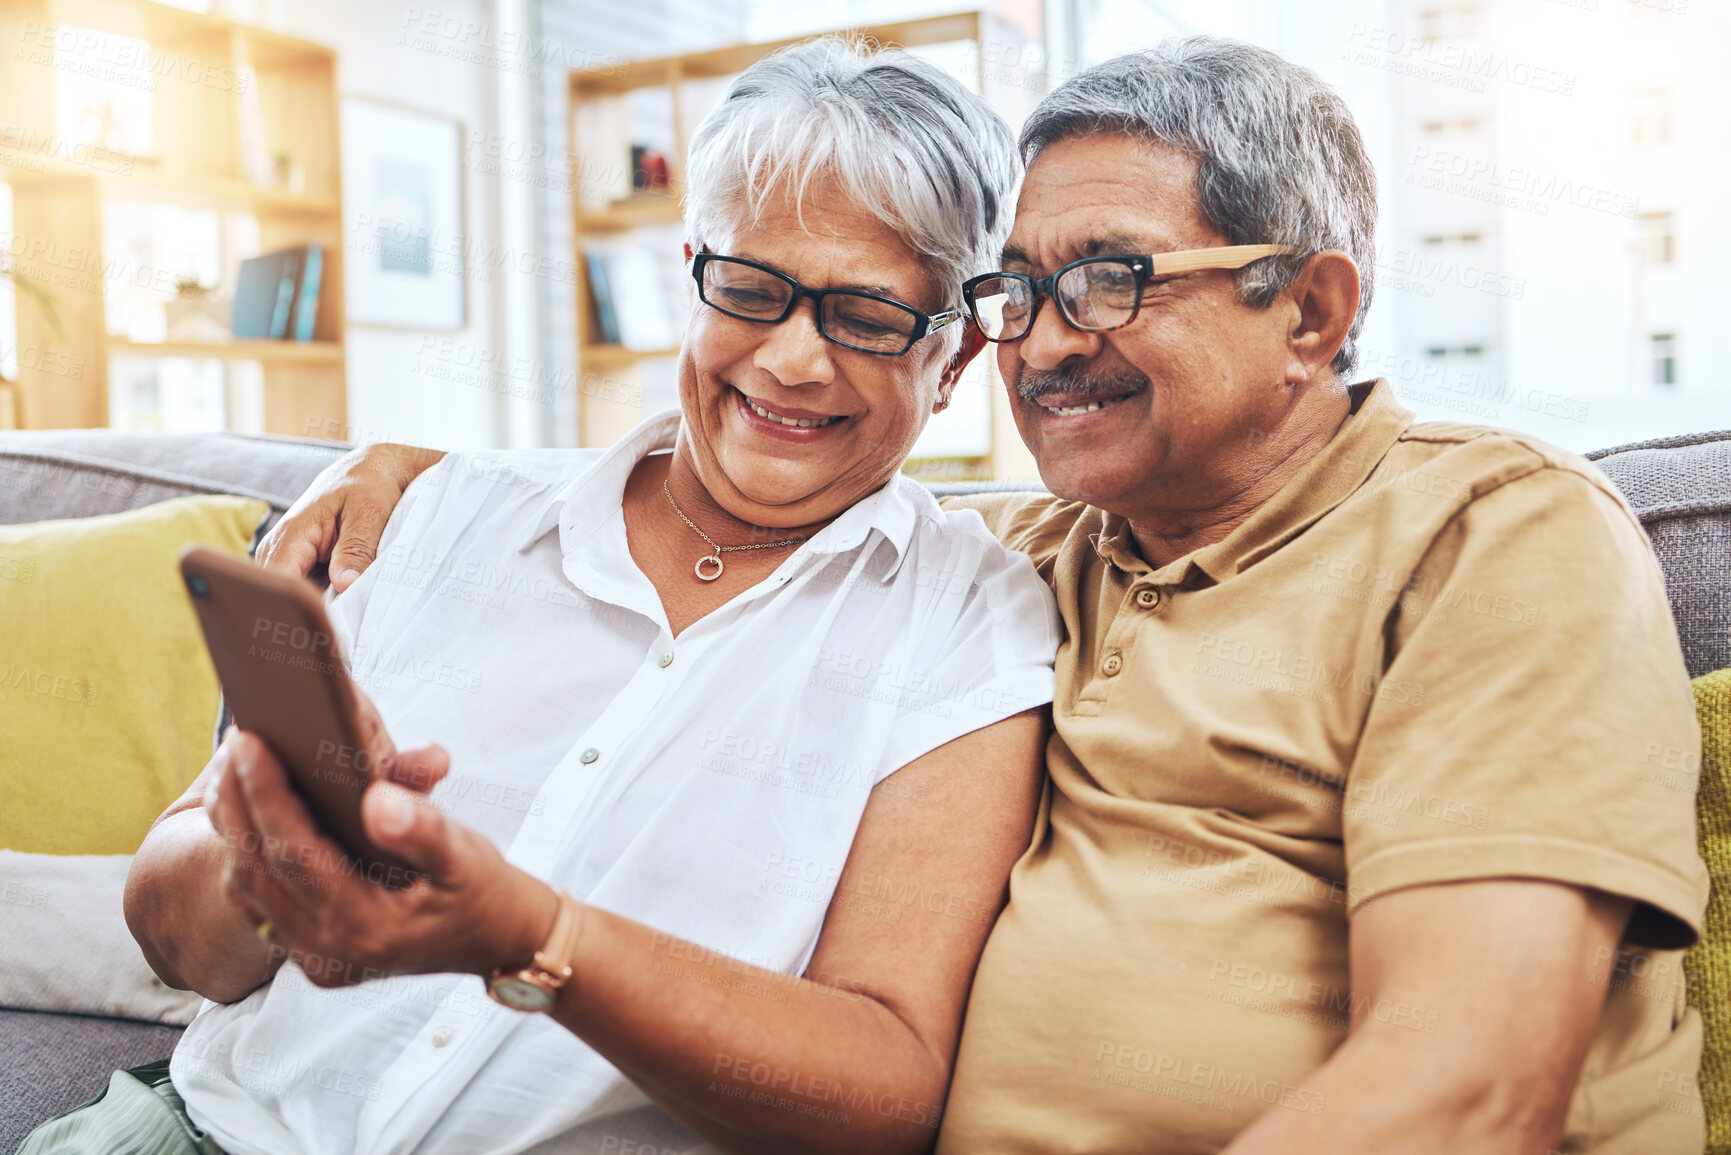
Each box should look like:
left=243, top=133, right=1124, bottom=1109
left=518, top=409, right=931, bottom=582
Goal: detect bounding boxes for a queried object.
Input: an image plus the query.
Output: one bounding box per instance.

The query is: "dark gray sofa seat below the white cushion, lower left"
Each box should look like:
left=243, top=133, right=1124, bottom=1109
left=0, top=1010, right=180, bottom=1152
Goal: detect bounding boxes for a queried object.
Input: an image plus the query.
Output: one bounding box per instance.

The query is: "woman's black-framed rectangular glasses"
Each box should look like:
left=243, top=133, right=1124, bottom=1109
left=691, top=253, right=966, bottom=357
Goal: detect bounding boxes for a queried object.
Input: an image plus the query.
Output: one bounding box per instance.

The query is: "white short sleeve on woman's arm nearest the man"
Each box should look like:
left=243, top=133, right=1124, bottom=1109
left=881, top=514, right=1058, bottom=778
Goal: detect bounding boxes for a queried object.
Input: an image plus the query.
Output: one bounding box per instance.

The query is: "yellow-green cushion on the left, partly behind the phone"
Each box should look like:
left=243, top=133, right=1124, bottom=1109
left=0, top=497, right=267, bottom=854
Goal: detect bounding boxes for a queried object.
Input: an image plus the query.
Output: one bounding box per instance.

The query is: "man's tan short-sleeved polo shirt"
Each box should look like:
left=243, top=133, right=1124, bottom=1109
left=938, top=383, right=1707, bottom=1155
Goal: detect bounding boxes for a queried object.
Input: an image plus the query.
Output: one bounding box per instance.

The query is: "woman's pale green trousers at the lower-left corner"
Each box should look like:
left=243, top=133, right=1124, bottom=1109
left=17, top=1058, right=223, bottom=1155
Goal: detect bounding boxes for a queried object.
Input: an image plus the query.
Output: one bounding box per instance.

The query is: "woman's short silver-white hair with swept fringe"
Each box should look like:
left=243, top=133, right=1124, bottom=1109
left=685, top=36, right=1021, bottom=349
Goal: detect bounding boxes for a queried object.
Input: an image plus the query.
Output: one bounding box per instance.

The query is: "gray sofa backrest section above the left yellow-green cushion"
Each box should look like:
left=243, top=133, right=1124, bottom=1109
left=0, top=429, right=348, bottom=525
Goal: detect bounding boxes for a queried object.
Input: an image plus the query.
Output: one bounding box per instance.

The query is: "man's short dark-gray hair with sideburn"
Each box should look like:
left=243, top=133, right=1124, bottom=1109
left=1021, top=36, right=1376, bottom=376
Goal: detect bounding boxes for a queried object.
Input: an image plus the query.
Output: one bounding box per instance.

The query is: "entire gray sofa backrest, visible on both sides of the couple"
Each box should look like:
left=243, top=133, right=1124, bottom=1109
left=0, top=429, right=1731, bottom=677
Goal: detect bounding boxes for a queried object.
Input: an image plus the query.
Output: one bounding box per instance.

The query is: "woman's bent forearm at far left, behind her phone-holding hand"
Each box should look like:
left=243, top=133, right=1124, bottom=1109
left=125, top=809, right=282, bottom=1003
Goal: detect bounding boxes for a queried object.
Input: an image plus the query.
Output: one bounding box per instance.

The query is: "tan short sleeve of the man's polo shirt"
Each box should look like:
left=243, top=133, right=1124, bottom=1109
left=1343, top=468, right=1708, bottom=949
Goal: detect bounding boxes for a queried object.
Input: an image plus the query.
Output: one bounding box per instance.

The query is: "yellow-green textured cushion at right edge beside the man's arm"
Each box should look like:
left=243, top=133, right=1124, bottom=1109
left=1683, top=668, right=1731, bottom=1155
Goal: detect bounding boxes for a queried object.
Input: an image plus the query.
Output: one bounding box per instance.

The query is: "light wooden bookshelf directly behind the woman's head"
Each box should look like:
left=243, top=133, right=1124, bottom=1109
left=568, top=12, right=997, bottom=478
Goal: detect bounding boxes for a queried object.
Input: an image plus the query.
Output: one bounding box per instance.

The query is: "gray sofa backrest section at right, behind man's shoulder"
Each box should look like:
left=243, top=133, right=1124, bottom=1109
left=1587, top=431, right=1731, bottom=677
